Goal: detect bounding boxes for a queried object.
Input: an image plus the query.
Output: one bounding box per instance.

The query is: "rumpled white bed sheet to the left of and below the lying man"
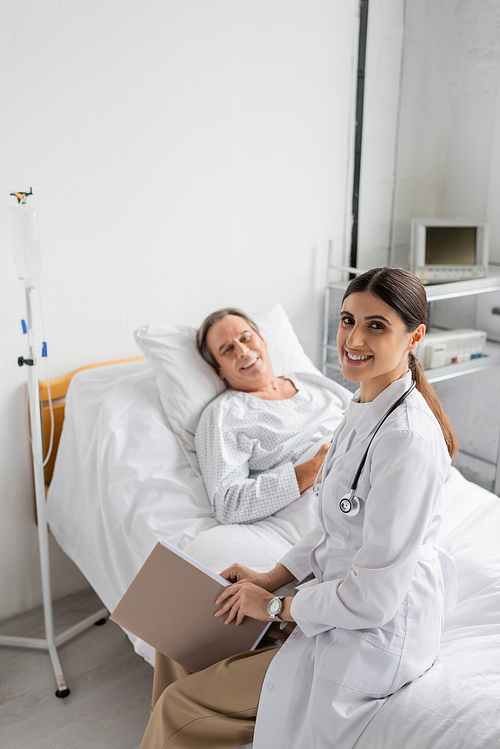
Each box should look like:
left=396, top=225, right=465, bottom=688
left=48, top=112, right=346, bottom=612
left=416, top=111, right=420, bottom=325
left=47, top=362, right=317, bottom=663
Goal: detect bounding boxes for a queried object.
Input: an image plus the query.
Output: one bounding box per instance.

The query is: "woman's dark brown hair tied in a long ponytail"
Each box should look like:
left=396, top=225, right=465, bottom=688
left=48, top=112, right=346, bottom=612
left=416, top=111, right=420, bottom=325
left=342, top=268, right=458, bottom=459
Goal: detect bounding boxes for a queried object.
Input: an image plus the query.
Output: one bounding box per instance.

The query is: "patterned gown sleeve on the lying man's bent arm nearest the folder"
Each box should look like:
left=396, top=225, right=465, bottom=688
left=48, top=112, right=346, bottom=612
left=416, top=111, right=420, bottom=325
left=196, top=400, right=300, bottom=524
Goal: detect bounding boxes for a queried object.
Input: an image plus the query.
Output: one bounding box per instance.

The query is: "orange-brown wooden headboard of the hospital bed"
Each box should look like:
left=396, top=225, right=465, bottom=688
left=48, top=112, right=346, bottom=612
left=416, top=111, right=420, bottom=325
left=39, top=356, right=146, bottom=492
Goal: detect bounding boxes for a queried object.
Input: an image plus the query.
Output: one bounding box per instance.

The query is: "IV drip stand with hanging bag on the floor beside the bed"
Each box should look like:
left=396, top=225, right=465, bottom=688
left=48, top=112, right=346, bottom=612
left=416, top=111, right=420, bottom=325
left=0, top=188, right=108, bottom=697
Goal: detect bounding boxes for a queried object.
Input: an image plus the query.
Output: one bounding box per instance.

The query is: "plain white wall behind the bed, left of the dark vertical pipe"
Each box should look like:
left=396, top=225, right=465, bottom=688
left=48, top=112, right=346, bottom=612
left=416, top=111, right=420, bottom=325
left=0, top=0, right=358, bottom=618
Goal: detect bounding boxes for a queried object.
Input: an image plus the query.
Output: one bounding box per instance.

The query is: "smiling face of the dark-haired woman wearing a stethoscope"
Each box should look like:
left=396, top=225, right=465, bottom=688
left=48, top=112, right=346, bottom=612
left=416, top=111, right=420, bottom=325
left=337, top=291, right=425, bottom=402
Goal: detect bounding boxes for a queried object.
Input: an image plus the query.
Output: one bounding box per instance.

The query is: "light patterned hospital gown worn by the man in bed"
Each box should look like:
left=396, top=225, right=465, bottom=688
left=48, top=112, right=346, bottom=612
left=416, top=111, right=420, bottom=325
left=195, top=372, right=351, bottom=524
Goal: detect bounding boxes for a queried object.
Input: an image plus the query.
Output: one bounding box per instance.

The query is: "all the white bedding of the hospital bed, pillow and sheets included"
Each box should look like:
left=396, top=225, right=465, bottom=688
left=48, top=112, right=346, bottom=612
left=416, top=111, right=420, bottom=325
left=48, top=306, right=500, bottom=749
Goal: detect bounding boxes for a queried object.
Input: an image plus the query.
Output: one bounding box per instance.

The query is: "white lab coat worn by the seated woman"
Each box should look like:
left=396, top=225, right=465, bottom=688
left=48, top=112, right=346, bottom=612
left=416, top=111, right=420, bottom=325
left=254, top=373, right=454, bottom=749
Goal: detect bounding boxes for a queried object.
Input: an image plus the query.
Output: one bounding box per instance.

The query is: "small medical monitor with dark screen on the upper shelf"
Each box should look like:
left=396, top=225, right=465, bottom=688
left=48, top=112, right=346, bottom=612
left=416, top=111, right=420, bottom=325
left=410, top=218, right=489, bottom=283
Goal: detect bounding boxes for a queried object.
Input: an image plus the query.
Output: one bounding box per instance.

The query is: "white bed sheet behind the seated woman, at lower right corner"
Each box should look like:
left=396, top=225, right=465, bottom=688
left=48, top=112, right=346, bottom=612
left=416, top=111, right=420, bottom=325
left=356, top=469, right=500, bottom=749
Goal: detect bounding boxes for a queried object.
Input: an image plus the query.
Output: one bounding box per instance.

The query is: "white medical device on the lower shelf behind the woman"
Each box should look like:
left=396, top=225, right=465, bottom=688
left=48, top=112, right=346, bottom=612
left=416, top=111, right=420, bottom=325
left=415, top=329, right=487, bottom=369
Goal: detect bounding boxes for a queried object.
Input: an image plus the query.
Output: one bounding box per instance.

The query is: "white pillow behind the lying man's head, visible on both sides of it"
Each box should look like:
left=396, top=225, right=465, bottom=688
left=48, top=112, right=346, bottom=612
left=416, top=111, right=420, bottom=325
left=134, top=304, right=319, bottom=475
